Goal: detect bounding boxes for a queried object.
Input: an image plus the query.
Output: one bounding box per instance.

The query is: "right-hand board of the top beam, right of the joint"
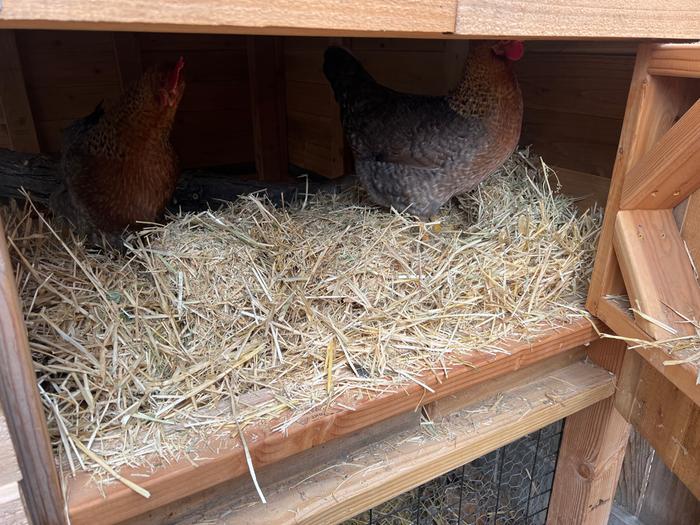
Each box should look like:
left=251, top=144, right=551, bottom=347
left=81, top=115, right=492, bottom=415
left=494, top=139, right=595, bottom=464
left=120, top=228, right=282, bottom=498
left=455, top=0, right=700, bottom=39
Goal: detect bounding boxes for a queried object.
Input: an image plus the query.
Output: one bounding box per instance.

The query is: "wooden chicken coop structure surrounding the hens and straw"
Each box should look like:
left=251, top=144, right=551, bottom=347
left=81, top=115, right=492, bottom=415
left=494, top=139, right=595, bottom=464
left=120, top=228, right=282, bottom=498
left=0, top=0, right=700, bottom=525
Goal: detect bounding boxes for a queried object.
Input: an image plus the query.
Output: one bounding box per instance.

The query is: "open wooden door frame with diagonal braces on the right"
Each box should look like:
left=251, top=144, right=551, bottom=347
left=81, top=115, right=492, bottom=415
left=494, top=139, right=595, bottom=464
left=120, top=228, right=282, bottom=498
left=587, top=44, right=700, bottom=404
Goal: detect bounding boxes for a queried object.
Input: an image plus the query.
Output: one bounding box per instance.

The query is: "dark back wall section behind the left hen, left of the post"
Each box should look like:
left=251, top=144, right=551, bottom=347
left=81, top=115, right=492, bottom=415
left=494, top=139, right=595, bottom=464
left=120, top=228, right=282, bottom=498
left=10, top=31, right=254, bottom=167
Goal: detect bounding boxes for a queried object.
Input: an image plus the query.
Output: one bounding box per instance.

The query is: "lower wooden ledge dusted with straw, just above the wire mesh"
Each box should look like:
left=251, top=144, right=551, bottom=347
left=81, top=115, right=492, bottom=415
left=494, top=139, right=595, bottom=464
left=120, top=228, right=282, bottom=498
left=216, top=362, right=615, bottom=525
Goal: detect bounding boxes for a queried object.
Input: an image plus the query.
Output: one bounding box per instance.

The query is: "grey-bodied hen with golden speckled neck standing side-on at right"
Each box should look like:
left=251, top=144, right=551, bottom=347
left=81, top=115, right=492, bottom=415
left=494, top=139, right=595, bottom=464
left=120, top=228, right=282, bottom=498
left=323, top=41, right=523, bottom=218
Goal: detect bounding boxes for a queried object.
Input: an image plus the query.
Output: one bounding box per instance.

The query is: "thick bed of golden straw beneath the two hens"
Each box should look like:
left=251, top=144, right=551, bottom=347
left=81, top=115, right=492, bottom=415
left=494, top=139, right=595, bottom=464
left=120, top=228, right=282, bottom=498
left=2, top=147, right=600, bottom=484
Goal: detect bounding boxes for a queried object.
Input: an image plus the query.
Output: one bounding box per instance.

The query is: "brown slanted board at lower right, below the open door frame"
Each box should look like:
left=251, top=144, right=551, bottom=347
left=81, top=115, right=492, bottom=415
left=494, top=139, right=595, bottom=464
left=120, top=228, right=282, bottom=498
left=615, top=353, right=700, bottom=498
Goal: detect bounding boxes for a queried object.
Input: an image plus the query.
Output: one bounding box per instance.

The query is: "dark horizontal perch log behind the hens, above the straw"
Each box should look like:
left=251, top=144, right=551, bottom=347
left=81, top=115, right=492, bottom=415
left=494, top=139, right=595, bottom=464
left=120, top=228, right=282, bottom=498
left=0, top=148, right=334, bottom=211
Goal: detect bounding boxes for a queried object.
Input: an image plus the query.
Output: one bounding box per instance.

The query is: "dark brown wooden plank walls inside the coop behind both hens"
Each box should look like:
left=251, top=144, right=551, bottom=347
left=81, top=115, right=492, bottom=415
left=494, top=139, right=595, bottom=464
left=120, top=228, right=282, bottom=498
left=8, top=31, right=636, bottom=186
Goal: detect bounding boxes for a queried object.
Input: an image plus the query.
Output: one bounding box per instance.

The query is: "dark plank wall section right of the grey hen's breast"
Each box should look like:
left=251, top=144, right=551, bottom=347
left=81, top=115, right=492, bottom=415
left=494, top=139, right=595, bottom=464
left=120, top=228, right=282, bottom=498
left=516, top=42, right=637, bottom=178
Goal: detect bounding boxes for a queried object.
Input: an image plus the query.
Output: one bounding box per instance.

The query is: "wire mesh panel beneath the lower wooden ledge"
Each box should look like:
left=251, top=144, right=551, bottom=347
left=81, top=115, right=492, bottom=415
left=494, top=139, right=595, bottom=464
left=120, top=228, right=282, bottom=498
left=343, top=420, right=563, bottom=525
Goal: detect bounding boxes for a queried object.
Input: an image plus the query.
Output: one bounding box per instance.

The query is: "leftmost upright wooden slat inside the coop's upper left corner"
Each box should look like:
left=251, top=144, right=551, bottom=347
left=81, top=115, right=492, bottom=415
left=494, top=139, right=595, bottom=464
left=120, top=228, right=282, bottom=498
left=0, top=30, right=39, bottom=153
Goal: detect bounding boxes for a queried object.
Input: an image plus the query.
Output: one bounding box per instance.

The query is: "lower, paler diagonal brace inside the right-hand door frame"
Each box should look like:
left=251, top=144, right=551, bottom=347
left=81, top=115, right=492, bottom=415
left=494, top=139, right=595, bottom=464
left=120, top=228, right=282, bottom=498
left=614, top=210, right=700, bottom=340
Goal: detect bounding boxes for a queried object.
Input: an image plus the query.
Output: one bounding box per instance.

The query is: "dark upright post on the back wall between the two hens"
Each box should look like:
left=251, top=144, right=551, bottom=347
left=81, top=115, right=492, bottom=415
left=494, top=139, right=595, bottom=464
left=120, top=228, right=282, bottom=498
left=248, top=36, right=289, bottom=181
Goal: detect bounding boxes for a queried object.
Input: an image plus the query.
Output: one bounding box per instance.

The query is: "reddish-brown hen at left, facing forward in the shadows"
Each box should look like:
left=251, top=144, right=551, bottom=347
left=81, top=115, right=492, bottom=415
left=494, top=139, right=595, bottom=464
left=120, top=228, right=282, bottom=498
left=50, top=58, right=185, bottom=246
